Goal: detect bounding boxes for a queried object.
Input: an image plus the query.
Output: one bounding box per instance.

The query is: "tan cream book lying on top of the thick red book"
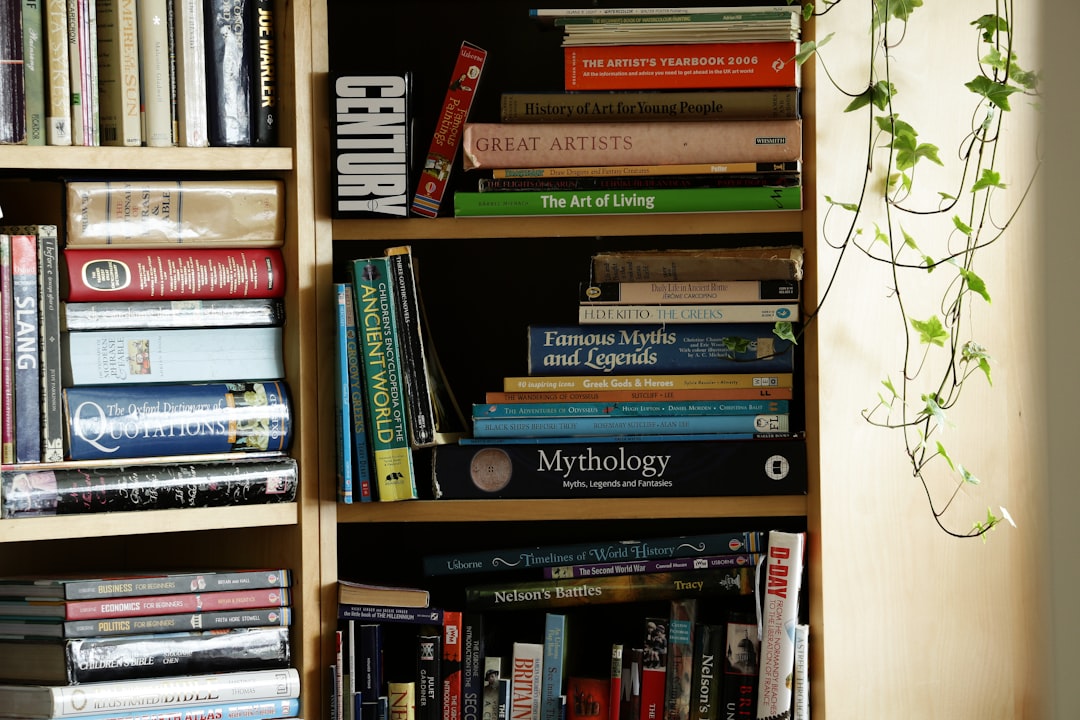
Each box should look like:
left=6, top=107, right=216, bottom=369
left=67, top=179, right=285, bottom=247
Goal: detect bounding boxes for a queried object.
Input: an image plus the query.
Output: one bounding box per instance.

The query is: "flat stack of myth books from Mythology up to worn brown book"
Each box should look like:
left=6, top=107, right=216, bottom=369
left=425, top=246, right=806, bottom=499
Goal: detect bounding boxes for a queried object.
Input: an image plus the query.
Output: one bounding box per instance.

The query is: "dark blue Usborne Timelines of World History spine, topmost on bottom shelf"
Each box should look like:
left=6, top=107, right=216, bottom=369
left=423, top=531, right=765, bottom=576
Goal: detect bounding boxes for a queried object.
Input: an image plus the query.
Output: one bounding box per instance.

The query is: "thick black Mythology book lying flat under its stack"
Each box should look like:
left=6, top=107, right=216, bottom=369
left=432, top=437, right=807, bottom=500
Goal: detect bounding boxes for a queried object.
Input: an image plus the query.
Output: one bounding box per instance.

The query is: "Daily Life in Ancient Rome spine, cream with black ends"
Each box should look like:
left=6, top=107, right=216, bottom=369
left=578, top=280, right=800, bottom=305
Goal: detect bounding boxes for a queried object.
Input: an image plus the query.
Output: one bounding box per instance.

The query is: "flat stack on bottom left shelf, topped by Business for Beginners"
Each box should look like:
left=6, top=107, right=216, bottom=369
left=0, top=569, right=300, bottom=720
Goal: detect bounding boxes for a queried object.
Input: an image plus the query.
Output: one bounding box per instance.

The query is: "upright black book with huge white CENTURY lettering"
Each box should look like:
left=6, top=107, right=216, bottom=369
left=329, top=72, right=415, bottom=218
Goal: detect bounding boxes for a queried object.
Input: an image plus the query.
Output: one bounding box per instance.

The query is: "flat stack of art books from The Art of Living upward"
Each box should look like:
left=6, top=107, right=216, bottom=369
left=455, top=5, right=802, bottom=217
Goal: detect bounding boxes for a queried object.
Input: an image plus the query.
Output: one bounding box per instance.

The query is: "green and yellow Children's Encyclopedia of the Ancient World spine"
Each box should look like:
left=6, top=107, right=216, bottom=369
left=352, top=257, right=418, bottom=501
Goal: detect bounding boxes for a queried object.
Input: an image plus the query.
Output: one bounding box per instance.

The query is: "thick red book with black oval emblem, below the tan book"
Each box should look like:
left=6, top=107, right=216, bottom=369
left=64, top=247, right=285, bottom=302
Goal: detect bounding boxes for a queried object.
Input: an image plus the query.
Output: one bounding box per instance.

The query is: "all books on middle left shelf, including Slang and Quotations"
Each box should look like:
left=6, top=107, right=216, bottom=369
left=0, top=180, right=297, bottom=517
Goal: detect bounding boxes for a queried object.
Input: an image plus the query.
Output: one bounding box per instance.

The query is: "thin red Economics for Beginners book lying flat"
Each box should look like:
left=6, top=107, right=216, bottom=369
left=0, top=587, right=289, bottom=620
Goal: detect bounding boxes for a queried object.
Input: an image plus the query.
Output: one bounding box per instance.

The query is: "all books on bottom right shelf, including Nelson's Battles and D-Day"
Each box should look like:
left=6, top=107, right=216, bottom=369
left=332, top=531, right=802, bottom=720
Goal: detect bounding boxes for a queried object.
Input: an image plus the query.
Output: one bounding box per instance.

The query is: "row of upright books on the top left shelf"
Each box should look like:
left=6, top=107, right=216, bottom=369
left=0, top=0, right=279, bottom=147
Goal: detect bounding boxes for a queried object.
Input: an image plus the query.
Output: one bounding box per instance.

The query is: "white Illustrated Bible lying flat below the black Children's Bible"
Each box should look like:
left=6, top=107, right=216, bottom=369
left=0, top=667, right=300, bottom=719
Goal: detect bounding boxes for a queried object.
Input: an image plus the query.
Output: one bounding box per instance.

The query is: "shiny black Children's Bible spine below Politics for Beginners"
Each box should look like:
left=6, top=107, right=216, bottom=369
left=67, top=627, right=291, bottom=683
